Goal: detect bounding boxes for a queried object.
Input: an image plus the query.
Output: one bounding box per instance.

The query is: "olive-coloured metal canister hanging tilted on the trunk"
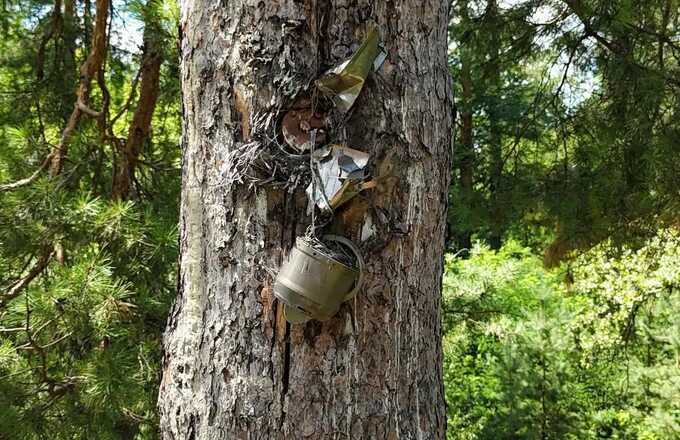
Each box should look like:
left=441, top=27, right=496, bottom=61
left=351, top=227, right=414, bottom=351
left=274, top=235, right=363, bottom=324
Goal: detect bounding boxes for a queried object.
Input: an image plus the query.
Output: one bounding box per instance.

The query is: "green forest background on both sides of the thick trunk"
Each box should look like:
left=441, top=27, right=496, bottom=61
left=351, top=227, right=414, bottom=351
left=0, top=0, right=680, bottom=439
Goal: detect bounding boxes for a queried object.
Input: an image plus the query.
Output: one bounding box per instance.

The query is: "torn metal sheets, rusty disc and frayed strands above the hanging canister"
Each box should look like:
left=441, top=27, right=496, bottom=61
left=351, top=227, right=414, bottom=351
left=222, top=27, right=386, bottom=211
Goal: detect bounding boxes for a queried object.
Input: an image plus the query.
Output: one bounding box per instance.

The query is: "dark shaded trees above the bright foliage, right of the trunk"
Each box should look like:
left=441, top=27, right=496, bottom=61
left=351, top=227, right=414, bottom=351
left=451, top=0, right=680, bottom=265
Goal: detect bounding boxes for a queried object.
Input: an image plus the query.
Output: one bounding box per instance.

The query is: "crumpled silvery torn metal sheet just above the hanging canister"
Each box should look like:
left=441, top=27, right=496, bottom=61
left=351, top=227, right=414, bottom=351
left=307, top=145, right=373, bottom=211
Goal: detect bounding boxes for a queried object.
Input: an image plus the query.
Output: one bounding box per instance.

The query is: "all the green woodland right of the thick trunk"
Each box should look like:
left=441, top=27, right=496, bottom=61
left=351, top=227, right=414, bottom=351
left=443, top=0, right=680, bottom=439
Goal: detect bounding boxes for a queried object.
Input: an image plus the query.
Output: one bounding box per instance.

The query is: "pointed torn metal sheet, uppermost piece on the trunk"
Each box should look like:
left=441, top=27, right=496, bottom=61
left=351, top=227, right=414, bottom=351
left=315, top=27, right=386, bottom=112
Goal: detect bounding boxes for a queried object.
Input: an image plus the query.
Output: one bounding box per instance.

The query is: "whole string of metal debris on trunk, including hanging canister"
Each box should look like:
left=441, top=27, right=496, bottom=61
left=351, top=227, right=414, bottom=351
left=266, top=27, right=387, bottom=324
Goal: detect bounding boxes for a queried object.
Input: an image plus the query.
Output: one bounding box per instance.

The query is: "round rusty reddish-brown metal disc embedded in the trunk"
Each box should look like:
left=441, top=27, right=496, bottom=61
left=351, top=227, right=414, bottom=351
left=281, top=98, right=326, bottom=153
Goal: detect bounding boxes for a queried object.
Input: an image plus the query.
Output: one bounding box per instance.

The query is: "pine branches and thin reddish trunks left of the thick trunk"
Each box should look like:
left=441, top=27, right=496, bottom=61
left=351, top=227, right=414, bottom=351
left=0, top=0, right=179, bottom=439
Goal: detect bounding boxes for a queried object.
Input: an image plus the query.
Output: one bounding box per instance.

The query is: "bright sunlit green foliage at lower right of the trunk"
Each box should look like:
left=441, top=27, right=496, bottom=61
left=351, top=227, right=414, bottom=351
left=443, top=231, right=680, bottom=440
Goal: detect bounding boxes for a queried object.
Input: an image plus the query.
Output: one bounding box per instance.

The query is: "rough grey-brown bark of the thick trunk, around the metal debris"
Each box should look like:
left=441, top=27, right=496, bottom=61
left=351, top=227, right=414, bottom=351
left=159, top=0, right=453, bottom=439
